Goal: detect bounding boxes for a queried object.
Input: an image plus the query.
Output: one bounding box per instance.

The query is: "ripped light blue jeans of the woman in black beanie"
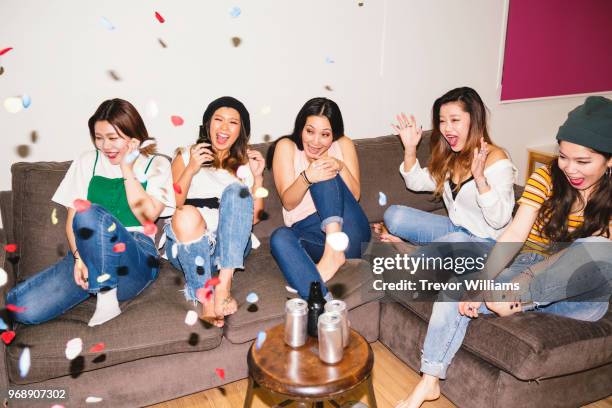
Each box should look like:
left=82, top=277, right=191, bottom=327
left=164, top=183, right=253, bottom=301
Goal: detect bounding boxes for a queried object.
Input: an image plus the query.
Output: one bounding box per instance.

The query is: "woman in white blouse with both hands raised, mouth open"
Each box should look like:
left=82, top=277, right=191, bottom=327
left=378, top=87, right=517, bottom=245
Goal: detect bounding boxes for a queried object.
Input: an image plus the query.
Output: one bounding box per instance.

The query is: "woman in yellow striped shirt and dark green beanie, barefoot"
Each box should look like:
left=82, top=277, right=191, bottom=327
left=397, top=97, right=612, bottom=408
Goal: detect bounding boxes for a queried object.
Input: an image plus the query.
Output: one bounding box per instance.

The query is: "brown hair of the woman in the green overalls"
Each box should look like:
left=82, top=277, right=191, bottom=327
left=87, top=98, right=157, bottom=156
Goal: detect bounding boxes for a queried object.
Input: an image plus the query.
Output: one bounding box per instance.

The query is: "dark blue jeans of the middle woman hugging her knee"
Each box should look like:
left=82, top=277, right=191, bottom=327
left=270, top=175, right=371, bottom=298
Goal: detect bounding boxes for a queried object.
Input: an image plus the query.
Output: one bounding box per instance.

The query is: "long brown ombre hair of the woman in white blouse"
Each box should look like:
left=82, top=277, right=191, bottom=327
left=428, top=87, right=493, bottom=197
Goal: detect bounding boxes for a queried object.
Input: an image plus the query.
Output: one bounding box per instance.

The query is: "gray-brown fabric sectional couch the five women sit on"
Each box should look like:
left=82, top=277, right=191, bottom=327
left=0, top=134, right=612, bottom=407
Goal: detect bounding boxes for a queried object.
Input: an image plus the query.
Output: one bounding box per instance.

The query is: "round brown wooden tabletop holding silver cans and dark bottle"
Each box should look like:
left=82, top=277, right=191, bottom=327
left=247, top=324, right=374, bottom=399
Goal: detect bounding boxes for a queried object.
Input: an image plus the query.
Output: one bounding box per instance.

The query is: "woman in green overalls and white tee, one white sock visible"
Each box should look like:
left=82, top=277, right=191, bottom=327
left=7, top=99, right=174, bottom=326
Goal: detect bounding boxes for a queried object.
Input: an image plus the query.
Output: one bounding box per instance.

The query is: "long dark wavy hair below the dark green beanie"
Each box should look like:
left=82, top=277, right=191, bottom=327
left=536, top=150, right=612, bottom=243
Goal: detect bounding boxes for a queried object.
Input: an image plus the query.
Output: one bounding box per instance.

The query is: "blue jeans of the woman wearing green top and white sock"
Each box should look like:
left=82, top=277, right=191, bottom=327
left=6, top=204, right=159, bottom=324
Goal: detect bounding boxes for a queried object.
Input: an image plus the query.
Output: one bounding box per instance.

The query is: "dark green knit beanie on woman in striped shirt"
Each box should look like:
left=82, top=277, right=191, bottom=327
left=557, top=96, right=612, bottom=153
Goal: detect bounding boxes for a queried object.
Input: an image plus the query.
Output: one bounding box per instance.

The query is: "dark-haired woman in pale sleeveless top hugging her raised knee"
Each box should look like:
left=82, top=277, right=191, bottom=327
left=270, top=98, right=370, bottom=298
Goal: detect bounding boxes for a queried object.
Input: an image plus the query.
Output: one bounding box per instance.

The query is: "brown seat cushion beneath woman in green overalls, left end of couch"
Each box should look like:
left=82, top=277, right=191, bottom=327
left=7, top=261, right=222, bottom=384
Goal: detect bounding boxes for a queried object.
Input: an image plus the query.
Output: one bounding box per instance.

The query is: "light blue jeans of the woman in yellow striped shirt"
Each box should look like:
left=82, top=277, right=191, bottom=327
left=421, top=238, right=612, bottom=379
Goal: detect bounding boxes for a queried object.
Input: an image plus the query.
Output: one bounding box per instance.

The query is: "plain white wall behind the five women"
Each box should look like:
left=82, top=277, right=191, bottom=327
left=0, top=0, right=612, bottom=198
